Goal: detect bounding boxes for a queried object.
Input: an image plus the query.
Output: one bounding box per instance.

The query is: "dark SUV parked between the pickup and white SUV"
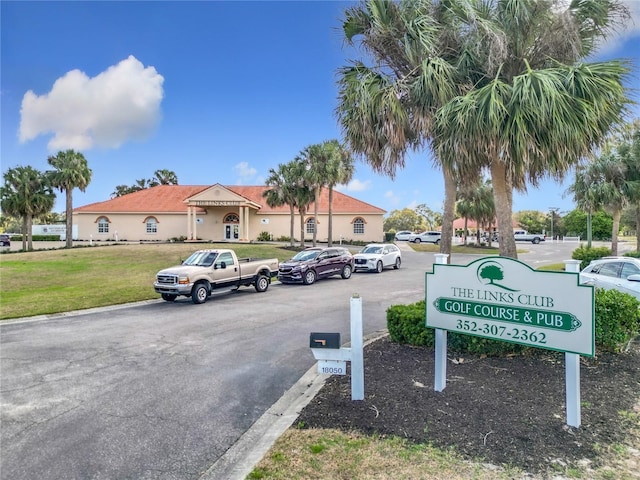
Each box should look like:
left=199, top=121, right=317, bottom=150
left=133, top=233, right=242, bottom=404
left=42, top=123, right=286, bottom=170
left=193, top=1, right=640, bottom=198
left=278, top=247, right=353, bottom=285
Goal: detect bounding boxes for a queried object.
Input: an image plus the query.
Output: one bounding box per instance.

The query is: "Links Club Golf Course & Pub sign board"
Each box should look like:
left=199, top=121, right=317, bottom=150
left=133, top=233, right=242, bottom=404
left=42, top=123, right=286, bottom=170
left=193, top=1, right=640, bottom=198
left=425, top=257, right=595, bottom=356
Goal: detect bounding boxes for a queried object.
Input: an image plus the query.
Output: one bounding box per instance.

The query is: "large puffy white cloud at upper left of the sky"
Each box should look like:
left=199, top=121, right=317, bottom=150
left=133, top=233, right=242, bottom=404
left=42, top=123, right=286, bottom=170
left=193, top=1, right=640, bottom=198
left=19, top=56, right=164, bottom=151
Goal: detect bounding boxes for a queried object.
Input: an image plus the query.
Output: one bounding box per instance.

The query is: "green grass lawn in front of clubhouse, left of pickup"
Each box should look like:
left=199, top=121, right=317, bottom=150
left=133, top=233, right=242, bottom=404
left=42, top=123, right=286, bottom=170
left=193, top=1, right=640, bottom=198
left=0, top=243, right=294, bottom=320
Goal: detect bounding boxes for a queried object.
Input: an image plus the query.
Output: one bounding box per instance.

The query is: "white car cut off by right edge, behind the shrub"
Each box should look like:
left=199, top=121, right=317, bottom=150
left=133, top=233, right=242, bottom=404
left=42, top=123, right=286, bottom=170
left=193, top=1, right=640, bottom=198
left=580, top=257, right=640, bottom=300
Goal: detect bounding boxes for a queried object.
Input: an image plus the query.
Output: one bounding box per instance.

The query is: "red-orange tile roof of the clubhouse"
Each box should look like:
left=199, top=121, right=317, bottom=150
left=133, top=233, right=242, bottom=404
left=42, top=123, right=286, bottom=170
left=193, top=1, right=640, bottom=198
left=73, top=185, right=386, bottom=214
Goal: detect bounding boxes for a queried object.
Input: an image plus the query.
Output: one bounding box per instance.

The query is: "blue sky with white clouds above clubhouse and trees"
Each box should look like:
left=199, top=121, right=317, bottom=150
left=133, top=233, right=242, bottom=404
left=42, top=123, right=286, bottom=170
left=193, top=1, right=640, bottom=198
left=0, top=0, right=640, bottom=218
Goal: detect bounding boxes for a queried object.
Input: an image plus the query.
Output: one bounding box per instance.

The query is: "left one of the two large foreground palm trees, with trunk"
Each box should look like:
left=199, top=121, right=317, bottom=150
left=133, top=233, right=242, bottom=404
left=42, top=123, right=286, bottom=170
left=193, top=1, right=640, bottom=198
left=336, top=0, right=490, bottom=261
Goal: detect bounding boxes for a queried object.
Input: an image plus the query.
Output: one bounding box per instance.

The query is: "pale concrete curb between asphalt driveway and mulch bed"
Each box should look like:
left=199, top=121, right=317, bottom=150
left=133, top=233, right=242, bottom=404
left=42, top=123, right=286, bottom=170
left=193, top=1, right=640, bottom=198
left=200, top=330, right=388, bottom=480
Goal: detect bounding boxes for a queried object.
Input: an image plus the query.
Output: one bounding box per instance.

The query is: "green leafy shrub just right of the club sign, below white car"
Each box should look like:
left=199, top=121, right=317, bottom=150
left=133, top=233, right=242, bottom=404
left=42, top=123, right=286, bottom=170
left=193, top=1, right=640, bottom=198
left=595, top=288, right=640, bottom=352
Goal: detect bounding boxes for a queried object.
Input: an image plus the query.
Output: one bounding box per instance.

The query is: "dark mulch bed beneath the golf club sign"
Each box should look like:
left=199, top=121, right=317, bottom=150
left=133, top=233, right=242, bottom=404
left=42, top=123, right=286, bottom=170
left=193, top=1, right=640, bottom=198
left=298, top=336, right=640, bottom=473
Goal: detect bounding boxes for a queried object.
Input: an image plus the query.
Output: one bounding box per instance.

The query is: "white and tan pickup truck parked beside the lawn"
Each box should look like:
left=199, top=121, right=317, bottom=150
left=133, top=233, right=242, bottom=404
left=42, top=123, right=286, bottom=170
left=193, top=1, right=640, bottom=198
left=153, top=249, right=279, bottom=303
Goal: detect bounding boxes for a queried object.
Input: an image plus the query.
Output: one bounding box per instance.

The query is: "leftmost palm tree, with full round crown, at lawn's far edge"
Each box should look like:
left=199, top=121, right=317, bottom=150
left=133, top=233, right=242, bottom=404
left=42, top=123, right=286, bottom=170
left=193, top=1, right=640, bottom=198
left=0, top=166, right=55, bottom=250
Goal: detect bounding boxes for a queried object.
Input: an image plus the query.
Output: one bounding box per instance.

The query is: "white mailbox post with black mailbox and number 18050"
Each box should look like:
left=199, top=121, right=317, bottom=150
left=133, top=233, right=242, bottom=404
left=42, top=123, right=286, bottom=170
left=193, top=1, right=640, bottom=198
left=309, top=294, right=364, bottom=400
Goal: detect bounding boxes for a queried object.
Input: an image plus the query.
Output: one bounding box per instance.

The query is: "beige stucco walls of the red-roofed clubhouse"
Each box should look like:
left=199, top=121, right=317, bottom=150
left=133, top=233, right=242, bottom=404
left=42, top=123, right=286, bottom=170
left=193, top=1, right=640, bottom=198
left=73, top=207, right=384, bottom=242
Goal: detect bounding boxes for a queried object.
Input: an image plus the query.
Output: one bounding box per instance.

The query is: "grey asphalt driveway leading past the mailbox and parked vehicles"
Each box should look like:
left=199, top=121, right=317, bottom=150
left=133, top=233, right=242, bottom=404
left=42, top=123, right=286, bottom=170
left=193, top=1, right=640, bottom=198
left=0, top=244, right=624, bottom=480
